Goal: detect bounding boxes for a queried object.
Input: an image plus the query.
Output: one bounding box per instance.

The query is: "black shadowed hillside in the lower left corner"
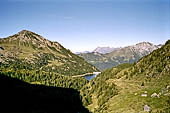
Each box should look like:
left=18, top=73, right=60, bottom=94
left=0, top=74, right=88, bottom=113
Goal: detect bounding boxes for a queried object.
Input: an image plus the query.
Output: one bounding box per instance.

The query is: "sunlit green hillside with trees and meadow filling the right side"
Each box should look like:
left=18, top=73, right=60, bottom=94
left=84, top=40, right=170, bottom=113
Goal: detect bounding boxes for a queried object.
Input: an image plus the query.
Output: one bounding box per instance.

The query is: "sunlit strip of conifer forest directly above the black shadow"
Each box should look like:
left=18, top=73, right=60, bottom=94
left=0, top=63, right=88, bottom=90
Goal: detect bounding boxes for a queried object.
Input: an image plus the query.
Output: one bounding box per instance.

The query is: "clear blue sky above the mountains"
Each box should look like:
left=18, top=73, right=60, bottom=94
left=0, top=0, right=170, bottom=52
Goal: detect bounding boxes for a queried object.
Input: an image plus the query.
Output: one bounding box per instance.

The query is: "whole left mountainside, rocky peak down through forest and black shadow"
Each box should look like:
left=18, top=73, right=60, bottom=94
left=0, top=30, right=94, bottom=113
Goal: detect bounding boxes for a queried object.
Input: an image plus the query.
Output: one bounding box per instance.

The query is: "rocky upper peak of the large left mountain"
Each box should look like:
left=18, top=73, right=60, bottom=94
left=0, top=30, right=63, bottom=51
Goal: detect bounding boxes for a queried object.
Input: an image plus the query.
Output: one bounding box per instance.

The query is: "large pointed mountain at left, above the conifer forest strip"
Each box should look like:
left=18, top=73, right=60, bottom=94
left=0, top=30, right=98, bottom=75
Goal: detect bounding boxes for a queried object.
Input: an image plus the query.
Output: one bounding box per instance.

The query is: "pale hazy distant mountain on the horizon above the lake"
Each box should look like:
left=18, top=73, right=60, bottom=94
left=93, top=47, right=120, bottom=54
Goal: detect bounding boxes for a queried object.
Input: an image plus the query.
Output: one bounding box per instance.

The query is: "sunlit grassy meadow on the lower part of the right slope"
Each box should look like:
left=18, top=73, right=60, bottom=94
left=89, top=70, right=170, bottom=113
